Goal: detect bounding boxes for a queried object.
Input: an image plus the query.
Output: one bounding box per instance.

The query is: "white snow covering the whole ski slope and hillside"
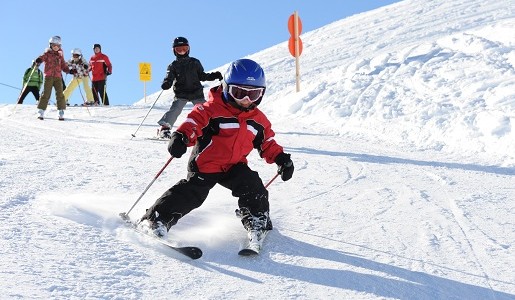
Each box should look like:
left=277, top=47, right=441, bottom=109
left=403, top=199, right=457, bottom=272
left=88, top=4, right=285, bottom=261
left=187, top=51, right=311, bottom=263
left=0, top=0, right=515, bottom=299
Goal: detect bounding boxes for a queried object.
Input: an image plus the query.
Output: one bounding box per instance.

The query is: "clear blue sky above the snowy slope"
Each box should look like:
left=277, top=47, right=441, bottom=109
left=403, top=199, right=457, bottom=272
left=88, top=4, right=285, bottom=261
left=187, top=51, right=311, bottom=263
left=0, top=0, right=399, bottom=105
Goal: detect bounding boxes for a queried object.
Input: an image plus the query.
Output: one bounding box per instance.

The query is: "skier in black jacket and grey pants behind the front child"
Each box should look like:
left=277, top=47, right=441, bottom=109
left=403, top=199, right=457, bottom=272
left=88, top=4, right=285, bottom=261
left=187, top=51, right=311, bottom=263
left=157, top=37, right=223, bottom=139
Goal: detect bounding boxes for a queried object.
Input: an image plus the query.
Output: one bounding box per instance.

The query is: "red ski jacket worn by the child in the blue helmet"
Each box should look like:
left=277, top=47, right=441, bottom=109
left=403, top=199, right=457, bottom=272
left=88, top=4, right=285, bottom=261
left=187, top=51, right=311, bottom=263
left=177, top=86, right=283, bottom=173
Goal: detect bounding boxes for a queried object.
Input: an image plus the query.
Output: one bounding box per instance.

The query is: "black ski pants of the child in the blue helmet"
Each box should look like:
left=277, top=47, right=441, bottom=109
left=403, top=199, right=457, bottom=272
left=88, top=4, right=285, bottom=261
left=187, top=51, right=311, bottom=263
left=143, top=163, right=270, bottom=228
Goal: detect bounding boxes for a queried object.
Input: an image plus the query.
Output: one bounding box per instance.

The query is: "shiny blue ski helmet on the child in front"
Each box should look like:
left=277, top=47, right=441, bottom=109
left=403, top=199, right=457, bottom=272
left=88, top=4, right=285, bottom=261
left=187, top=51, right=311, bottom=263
left=222, top=58, right=266, bottom=107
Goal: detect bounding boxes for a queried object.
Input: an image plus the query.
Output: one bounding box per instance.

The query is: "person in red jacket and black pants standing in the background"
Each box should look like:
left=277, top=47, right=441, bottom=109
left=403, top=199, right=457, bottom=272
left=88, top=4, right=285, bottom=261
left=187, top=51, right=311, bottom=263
left=89, top=44, right=113, bottom=105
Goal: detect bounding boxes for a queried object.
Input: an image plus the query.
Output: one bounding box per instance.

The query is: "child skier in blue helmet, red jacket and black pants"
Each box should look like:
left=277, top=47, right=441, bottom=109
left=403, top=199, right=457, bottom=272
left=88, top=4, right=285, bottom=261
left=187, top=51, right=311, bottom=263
left=139, top=59, right=294, bottom=237
